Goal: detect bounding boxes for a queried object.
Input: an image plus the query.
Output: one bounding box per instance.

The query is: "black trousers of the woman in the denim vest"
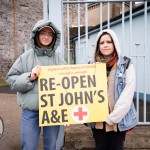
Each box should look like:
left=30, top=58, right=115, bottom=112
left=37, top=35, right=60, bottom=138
left=92, top=128, right=126, bottom=150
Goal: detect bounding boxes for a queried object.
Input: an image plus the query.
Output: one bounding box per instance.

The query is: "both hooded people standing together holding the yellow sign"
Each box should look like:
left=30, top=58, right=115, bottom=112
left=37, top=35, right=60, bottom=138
left=7, top=17, right=138, bottom=150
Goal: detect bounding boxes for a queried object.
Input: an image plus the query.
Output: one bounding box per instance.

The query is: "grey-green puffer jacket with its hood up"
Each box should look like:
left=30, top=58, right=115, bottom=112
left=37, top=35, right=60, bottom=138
left=6, top=20, right=66, bottom=110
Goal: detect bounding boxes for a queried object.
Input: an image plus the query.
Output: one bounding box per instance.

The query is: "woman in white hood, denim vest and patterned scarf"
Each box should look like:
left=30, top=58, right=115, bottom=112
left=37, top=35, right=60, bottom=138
left=87, top=29, right=138, bottom=150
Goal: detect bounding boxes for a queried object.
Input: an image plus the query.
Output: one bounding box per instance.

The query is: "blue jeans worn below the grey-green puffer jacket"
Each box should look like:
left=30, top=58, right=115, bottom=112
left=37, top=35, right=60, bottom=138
left=21, top=110, right=59, bottom=150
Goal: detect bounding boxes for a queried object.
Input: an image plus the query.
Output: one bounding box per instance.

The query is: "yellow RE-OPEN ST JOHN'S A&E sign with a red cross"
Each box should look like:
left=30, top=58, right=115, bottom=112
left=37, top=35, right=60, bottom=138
left=38, top=63, right=108, bottom=126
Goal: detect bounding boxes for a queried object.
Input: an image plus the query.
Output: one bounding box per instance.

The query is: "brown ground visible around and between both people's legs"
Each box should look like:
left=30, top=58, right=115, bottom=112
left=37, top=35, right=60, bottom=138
left=0, top=86, right=150, bottom=150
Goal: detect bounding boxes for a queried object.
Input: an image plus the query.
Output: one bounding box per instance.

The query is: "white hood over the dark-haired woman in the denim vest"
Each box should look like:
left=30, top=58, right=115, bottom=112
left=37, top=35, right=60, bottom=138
left=95, top=29, right=120, bottom=63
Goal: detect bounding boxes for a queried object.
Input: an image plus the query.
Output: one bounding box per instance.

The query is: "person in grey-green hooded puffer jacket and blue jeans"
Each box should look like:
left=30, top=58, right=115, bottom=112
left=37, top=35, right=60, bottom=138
left=6, top=20, right=66, bottom=150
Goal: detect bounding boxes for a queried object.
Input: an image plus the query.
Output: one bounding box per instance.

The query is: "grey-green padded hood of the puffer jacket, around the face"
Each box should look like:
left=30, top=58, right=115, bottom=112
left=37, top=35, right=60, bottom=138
left=30, top=20, right=60, bottom=56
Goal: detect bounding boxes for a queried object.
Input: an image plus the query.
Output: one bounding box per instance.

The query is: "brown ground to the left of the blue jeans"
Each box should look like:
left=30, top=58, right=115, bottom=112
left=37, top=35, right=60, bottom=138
left=0, top=93, right=21, bottom=150
